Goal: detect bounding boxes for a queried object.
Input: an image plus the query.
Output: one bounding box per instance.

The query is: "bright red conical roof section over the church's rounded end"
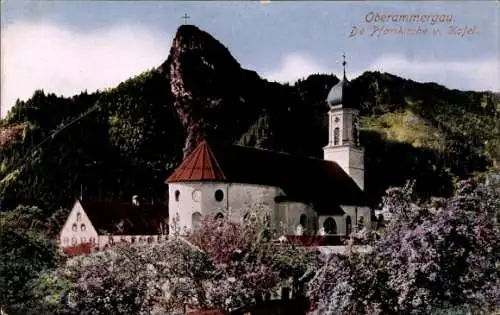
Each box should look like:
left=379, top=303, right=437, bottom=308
left=168, top=141, right=226, bottom=182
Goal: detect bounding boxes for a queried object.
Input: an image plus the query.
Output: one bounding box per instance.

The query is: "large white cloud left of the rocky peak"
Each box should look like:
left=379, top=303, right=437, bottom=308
left=1, top=23, right=171, bottom=117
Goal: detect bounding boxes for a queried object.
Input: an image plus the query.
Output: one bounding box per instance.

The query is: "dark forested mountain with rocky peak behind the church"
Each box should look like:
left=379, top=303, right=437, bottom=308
left=0, top=25, right=500, bottom=215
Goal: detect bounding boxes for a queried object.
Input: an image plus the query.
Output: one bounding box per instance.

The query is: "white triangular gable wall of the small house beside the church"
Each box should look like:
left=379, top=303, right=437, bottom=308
left=59, top=201, right=97, bottom=247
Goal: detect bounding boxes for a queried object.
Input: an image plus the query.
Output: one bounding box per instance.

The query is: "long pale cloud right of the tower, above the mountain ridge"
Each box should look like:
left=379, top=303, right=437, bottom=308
left=370, top=56, right=500, bottom=91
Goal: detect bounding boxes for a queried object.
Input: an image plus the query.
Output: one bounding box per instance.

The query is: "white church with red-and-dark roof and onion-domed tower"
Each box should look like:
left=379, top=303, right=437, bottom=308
left=166, top=60, right=375, bottom=236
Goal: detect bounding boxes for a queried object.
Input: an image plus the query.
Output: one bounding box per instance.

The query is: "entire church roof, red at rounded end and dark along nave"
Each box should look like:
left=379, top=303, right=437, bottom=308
left=166, top=141, right=367, bottom=213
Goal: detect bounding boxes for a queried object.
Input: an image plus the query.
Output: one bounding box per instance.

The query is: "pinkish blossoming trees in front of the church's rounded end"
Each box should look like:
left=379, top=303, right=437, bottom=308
left=44, top=214, right=315, bottom=314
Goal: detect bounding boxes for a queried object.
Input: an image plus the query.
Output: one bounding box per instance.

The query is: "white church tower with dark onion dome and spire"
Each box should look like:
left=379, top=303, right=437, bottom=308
left=323, top=54, right=365, bottom=190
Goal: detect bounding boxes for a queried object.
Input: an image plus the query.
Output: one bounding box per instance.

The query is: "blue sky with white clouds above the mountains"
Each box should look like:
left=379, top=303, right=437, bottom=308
left=0, top=0, right=500, bottom=117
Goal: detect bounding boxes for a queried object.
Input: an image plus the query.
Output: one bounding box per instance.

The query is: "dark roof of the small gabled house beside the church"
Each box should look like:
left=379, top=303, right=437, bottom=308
left=79, top=200, right=168, bottom=235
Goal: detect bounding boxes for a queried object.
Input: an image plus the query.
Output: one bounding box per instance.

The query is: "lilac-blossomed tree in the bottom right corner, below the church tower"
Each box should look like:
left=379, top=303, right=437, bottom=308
left=311, top=180, right=500, bottom=314
